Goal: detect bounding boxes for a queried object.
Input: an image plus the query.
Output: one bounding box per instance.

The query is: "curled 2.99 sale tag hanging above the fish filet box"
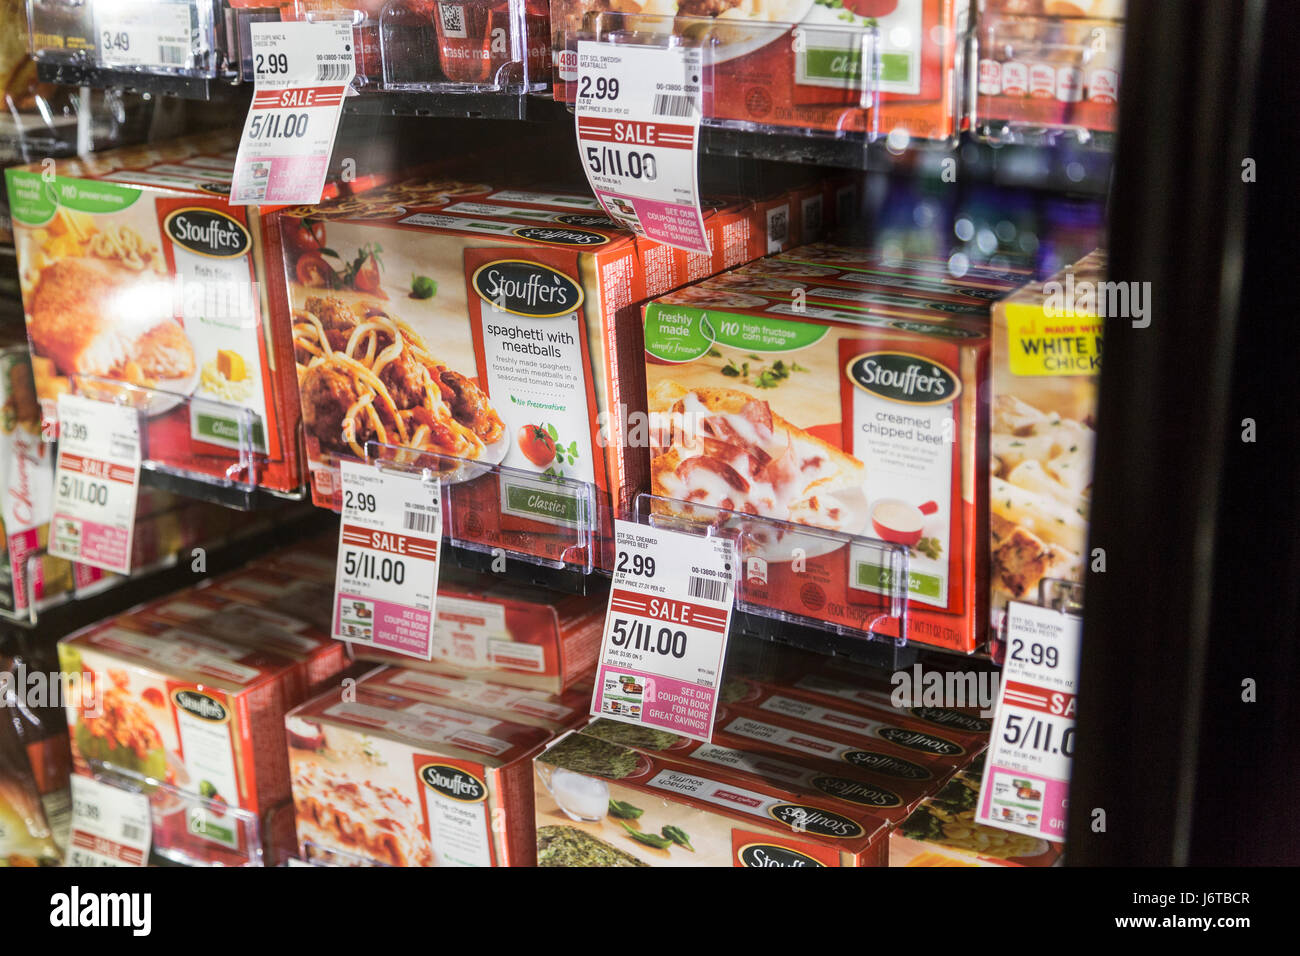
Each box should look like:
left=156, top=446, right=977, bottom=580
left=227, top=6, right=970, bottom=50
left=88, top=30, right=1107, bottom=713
left=230, top=20, right=356, bottom=206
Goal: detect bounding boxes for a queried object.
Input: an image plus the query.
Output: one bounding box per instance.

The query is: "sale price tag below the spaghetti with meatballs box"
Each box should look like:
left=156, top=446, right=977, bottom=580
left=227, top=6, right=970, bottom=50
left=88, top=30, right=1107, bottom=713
left=334, top=462, right=442, bottom=661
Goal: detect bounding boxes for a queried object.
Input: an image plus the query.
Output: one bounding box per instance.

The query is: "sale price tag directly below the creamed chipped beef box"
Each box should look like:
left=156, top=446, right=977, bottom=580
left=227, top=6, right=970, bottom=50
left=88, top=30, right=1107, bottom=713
left=592, top=520, right=736, bottom=740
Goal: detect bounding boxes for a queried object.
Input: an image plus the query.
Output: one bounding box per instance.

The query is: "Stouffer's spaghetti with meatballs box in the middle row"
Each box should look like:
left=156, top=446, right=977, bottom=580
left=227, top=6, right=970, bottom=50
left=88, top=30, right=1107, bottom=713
left=285, top=180, right=655, bottom=563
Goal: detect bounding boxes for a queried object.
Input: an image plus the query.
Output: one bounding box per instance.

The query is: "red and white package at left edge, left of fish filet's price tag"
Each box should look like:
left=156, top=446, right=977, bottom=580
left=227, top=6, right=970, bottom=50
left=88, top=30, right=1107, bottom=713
left=0, top=336, right=73, bottom=614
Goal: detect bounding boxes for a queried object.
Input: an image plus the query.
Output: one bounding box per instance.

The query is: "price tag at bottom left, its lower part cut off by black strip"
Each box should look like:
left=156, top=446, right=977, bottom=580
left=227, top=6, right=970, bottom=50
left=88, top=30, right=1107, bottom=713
left=68, top=774, right=153, bottom=866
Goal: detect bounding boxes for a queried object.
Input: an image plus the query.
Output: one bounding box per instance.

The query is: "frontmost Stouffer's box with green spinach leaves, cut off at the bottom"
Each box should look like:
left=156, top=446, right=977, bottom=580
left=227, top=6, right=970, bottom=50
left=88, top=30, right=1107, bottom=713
left=533, top=732, right=888, bottom=866
